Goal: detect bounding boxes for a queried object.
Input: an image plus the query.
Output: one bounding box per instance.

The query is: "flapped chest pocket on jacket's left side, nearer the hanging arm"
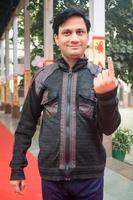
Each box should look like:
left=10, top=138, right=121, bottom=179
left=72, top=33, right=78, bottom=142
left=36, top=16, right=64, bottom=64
left=41, top=90, right=58, bottom=117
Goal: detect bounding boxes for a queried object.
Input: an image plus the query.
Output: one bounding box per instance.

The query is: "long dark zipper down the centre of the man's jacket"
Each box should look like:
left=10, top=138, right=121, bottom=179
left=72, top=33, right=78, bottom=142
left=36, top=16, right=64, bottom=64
left=65, top=71, right=72, bottom=180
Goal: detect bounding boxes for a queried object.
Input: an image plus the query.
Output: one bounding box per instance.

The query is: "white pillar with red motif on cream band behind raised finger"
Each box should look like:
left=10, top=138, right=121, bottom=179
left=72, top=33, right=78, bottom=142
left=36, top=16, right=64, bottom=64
left=89, top=0, right=105, bottom=67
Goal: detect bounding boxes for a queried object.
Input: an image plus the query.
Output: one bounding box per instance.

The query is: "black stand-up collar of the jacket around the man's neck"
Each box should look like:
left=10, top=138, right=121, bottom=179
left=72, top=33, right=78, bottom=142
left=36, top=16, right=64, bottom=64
left=57, top=57, right=88, bottom=72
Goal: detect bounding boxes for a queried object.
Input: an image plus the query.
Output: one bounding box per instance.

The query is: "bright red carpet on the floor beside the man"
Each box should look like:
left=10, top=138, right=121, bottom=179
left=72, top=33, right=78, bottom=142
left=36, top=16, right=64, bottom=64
left=0, top=122, right=42, bottom=200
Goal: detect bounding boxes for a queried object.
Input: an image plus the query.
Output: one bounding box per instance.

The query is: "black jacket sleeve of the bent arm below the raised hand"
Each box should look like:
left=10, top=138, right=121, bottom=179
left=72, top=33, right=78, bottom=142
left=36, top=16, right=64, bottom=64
left=96, top=88, right=121, bottom=135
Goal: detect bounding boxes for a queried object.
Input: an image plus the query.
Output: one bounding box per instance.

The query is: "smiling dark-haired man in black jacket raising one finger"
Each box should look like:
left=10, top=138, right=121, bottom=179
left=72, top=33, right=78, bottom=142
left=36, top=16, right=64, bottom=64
left=10, top=8, right=120, bottom=200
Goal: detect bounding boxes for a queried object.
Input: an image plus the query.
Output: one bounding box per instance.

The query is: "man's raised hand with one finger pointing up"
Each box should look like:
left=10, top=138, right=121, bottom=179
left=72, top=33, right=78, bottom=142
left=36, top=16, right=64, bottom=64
left=94, top=57, right=118, bottom=94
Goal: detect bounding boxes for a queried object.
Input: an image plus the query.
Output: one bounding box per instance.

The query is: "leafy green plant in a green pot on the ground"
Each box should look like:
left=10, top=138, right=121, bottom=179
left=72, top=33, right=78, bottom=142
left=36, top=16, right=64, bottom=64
left=112, top=128, right=133, bottom=161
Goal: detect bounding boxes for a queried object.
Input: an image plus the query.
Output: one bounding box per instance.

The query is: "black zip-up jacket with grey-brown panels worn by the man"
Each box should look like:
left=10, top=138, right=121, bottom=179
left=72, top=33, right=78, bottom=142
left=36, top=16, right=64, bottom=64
left=10, top=58, right=120, bottom=181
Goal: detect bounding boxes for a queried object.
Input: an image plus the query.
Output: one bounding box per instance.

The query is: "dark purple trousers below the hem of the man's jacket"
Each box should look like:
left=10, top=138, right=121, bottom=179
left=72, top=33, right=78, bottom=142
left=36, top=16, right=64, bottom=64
left=42, top=177, right=103, bottom=200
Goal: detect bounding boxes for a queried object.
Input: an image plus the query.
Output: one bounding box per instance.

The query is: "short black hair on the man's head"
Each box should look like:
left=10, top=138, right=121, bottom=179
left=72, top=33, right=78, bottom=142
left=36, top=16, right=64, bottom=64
left=53, top=8, right=91, bottom=35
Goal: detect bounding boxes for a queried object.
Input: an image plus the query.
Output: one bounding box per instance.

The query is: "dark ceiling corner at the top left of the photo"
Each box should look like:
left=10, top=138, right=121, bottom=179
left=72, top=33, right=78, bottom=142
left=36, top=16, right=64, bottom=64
left=0, top=0, right=20, bottom=38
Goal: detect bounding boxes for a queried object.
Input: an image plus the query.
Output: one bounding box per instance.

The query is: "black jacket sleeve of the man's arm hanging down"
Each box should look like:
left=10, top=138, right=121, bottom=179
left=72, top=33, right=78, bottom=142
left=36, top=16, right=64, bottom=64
left=10, top=81, right=42, bottom=180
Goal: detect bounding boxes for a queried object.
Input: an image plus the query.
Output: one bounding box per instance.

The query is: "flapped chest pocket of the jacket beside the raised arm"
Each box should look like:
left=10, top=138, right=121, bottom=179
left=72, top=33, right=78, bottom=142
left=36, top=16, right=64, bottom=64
left=78, top=89, right=96, bottom=119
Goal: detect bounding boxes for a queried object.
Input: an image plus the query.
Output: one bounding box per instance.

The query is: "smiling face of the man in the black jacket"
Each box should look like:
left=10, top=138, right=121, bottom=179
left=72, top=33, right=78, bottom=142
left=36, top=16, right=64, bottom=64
left=55, top=16, right=89, bottom=61
